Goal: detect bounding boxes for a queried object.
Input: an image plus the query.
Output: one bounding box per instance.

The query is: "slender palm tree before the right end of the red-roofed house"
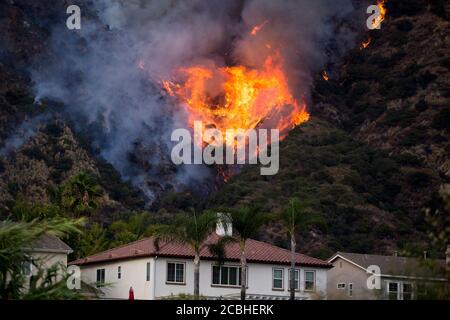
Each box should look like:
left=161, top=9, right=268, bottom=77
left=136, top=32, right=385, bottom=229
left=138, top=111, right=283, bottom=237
left=281, top=198, right=306, bottom=300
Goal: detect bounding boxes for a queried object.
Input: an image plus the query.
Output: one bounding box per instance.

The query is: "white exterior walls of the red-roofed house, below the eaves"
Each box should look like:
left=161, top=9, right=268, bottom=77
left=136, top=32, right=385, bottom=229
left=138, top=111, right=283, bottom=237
left=81, top=257, right=327, bottom=299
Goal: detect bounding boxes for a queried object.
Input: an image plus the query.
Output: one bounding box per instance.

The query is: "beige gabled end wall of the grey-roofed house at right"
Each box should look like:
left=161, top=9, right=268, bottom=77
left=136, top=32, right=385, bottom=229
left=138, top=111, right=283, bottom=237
left=327, top=257, right=380, bottom=300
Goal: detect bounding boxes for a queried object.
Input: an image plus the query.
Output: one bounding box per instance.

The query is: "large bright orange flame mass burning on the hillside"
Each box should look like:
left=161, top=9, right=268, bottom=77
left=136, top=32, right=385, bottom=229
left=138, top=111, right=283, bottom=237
left=162, top=54, right=309, bottom=141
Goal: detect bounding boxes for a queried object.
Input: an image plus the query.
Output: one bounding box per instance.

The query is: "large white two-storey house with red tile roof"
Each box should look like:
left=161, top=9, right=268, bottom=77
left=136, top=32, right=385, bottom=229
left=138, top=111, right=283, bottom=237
left=71, top=222, right=331, bottom=299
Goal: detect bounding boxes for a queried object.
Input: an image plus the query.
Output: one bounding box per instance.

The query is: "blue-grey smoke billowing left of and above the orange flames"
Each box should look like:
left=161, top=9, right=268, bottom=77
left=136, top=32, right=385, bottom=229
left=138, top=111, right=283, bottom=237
left=33, top=0, right=362, bottom=201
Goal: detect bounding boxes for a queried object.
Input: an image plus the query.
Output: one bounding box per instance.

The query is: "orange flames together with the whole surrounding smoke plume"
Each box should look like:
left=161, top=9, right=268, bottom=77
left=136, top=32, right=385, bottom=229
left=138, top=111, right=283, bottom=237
left=27, top=0, right=358, bottom=202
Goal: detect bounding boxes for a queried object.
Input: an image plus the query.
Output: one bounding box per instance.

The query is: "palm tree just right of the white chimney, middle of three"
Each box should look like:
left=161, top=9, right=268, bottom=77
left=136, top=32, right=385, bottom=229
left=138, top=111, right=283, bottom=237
left=230, top=206, right=271, bottom=300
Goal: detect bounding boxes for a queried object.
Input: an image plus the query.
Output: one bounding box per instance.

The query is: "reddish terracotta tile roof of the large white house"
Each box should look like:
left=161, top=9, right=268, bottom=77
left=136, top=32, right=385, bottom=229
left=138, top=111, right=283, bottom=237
left=70, top=233, right=332, bottom=268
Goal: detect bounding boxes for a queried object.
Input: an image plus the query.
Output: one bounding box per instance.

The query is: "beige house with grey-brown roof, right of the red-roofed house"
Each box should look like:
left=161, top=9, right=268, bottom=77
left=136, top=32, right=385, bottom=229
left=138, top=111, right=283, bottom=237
left=327, top=252, right=447, bottom=300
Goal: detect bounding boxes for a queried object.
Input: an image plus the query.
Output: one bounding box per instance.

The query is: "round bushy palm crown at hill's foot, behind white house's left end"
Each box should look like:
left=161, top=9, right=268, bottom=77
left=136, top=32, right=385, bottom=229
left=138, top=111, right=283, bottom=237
left=60, top=172, right=102, bottom=216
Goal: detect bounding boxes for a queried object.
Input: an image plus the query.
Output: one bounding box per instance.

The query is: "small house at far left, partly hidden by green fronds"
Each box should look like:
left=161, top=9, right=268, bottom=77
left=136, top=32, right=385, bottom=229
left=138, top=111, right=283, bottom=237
left=24, top=235, right=72, bottom=277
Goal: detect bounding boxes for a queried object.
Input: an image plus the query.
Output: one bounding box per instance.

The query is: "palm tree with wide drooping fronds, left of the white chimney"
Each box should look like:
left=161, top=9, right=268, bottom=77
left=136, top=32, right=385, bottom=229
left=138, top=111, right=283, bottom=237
left=150, top=210, right=218, bottom=300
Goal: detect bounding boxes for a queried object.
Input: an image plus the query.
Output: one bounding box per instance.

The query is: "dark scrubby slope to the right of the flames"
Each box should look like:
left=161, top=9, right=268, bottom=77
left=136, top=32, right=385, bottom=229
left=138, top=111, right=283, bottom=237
left=206, top=4, right=450, bottom=257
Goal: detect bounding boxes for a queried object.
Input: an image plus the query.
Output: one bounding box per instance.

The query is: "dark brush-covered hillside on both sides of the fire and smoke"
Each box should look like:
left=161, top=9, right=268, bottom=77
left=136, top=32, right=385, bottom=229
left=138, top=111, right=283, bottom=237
left=0, top=0, right=450, bottom=258
